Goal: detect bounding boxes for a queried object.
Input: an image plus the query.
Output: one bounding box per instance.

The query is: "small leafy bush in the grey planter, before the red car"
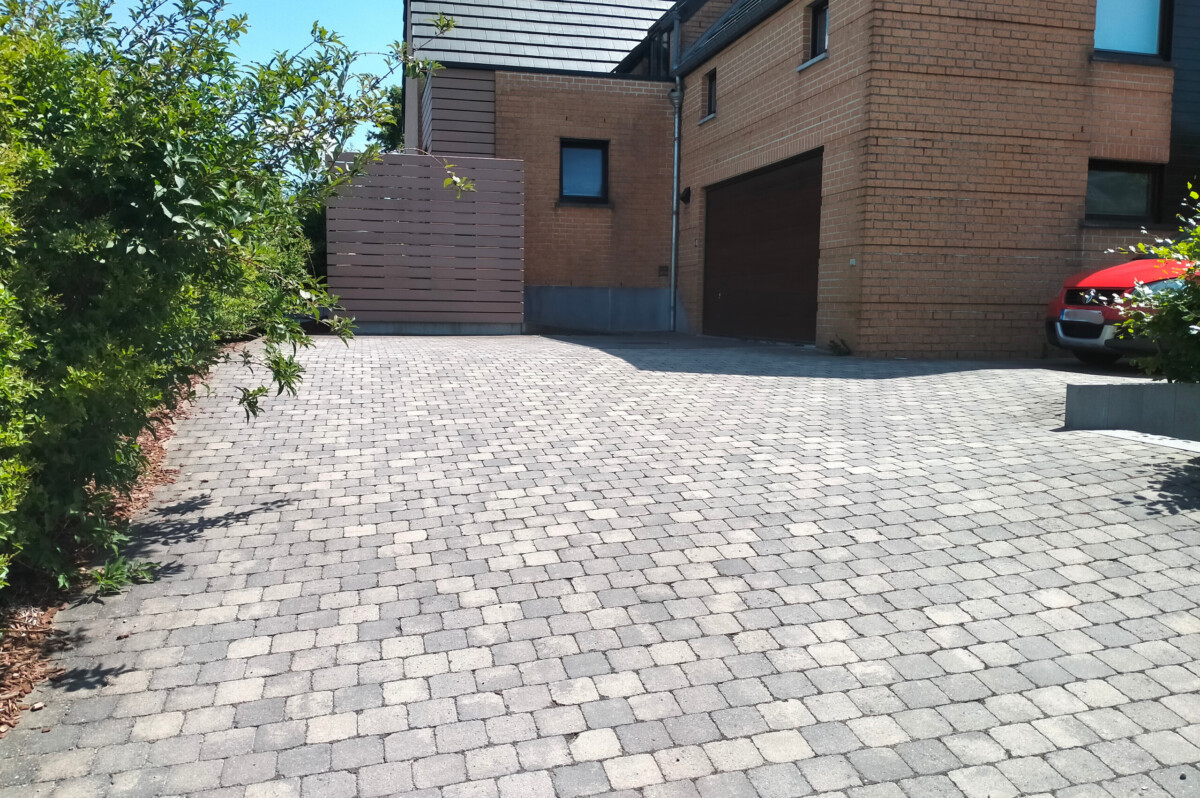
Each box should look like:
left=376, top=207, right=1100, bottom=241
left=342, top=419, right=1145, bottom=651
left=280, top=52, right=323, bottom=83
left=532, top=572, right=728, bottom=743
left=1118, top=186, right=1200, bottom=383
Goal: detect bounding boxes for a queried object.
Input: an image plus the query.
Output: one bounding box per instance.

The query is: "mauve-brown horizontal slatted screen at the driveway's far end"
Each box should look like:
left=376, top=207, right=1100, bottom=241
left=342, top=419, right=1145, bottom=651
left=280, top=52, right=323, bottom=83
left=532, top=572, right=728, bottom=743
left=326, top=155, right=524, bottom=325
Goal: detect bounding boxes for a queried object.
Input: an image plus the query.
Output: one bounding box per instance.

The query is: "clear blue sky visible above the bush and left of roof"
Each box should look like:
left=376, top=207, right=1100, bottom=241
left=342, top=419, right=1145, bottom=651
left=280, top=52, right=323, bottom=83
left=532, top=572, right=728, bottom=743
left=113, top=0, right=404, bottom=144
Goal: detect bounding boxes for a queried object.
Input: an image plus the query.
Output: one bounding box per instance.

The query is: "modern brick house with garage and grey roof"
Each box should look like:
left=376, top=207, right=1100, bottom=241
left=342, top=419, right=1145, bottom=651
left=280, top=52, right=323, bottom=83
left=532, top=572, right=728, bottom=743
left=360, top=0, right=1200, bottom=358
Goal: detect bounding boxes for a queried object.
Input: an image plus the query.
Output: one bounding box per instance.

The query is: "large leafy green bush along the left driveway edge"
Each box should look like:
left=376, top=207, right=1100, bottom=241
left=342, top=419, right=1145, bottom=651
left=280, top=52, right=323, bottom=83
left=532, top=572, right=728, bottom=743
left=0, top=0, right=441, bottom=587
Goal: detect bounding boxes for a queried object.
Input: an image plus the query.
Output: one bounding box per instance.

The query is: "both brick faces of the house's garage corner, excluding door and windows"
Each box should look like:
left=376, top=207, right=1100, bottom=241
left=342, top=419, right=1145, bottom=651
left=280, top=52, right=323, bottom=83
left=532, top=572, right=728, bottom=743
left=680, top=0, right=1172, bottom=356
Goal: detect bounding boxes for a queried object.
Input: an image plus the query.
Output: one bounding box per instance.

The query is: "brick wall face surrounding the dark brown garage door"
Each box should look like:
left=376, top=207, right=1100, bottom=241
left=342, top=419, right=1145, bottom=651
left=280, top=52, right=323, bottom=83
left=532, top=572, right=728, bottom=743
left=679, top=0, right=871, bottom=346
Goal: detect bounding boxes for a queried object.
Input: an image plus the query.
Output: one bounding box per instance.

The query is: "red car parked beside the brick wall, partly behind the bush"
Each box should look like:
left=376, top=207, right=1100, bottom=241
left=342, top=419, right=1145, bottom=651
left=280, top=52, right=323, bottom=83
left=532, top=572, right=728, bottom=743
left=1046, top=259, right=1188, bottom=366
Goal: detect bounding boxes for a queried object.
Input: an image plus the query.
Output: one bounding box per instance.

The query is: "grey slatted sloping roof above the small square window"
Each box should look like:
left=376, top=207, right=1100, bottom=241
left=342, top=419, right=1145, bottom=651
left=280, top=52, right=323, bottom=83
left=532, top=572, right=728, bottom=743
left=409, top=0, right=674, bottom=72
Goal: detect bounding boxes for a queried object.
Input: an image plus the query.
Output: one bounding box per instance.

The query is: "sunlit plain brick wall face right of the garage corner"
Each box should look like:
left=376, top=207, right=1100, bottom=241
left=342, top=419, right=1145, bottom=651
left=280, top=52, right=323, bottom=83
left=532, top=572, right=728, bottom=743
left=859, top=0, right=1171, bottom=356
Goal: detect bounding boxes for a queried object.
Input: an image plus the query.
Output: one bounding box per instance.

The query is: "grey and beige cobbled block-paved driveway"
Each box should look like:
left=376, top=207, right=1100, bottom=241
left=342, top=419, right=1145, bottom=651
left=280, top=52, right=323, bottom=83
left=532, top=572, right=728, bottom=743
left=0, top=338, right=1200, bottom=798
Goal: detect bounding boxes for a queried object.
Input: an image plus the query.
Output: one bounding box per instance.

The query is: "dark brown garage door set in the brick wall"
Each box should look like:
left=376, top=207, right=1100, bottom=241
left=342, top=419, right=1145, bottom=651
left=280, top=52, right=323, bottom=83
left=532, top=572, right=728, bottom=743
left=704, top=154, right=821, bottom=343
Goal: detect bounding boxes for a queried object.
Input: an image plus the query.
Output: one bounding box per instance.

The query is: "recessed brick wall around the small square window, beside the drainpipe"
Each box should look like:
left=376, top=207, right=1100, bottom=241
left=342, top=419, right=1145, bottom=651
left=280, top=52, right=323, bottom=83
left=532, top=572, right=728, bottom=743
left=496, top=72, right=673, bottom=288
